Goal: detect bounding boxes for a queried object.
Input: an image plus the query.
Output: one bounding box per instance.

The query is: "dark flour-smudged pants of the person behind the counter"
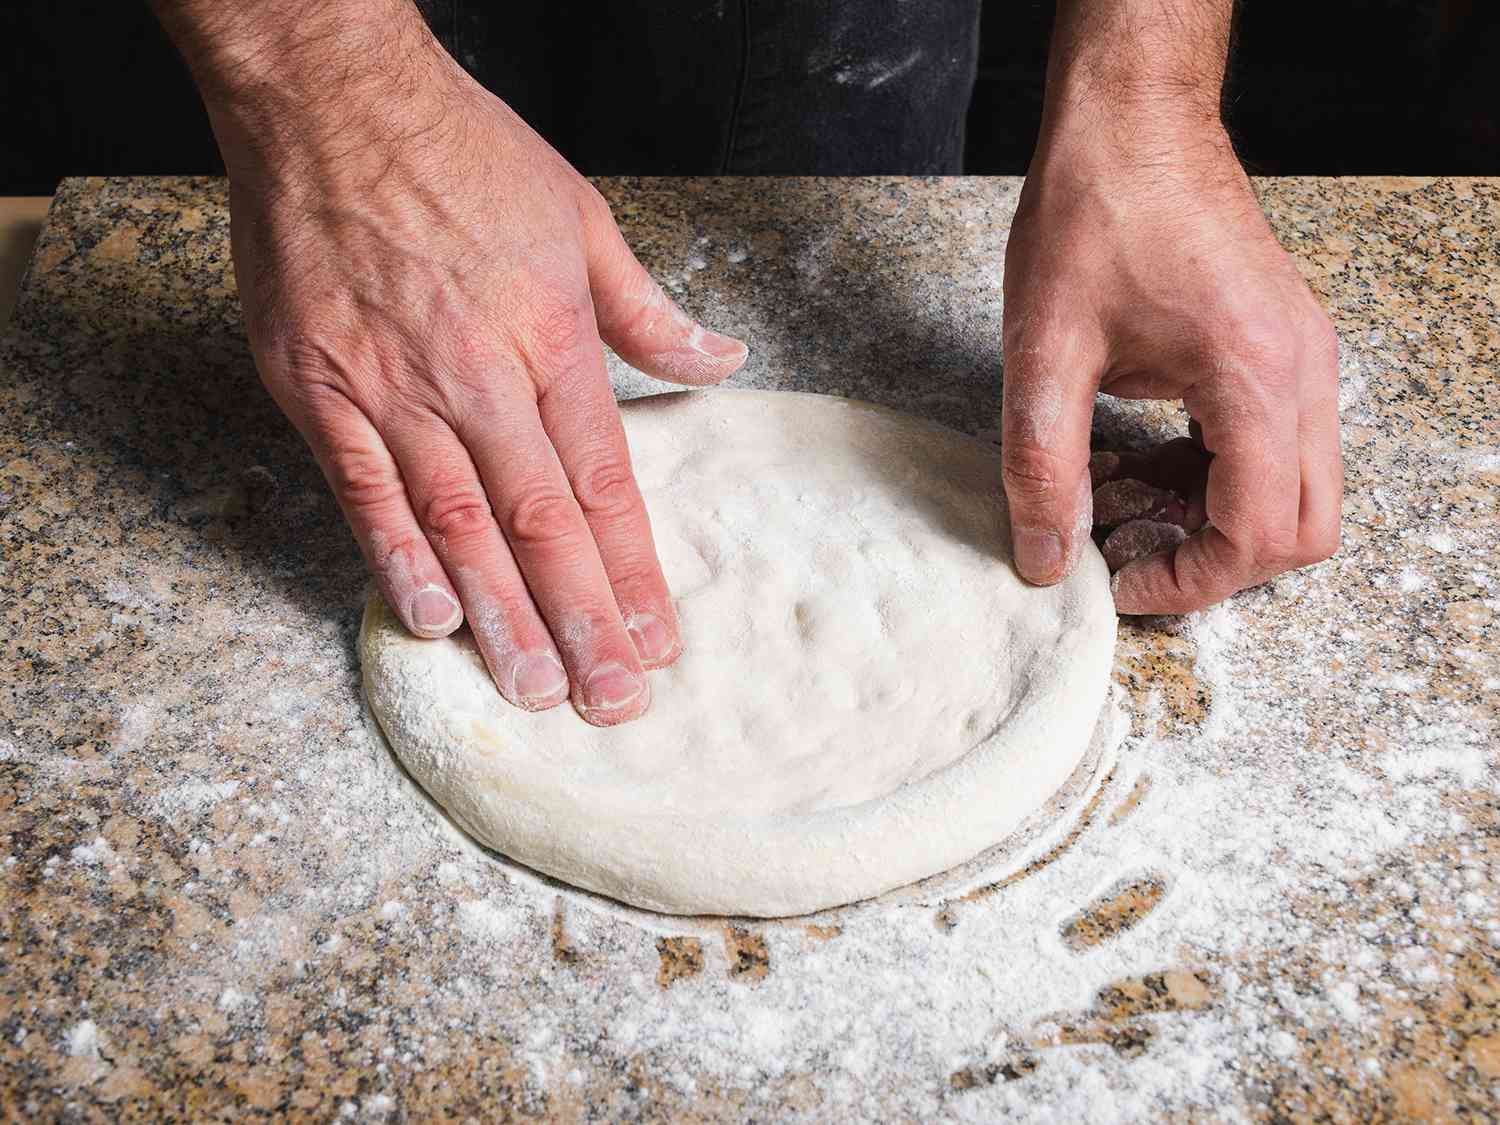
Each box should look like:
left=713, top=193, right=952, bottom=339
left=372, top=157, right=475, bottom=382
left=419, top=0, right=980, bottom=176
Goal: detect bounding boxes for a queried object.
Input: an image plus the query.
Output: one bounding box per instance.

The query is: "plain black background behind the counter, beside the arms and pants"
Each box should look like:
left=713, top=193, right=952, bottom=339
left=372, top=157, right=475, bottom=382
left=0, top=0, right=1500, bottom=195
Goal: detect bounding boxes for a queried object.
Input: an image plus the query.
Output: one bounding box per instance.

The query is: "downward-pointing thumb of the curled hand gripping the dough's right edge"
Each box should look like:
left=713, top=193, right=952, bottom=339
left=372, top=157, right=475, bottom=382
left=1001, top=318, right=1103, bottom=587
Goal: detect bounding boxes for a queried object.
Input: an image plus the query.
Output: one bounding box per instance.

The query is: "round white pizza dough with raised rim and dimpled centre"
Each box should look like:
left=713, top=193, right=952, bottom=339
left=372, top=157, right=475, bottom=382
left=360, top=390, right=1115, bottom=917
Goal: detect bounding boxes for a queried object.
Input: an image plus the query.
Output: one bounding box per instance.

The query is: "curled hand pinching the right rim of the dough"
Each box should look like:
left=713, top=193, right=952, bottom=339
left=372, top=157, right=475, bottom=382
left=1002, top=122, right=1343, bottom=614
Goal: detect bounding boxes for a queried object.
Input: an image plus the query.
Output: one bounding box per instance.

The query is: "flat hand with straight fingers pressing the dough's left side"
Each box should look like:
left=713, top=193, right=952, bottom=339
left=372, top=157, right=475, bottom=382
left=193, top=5, right=746, bottom=725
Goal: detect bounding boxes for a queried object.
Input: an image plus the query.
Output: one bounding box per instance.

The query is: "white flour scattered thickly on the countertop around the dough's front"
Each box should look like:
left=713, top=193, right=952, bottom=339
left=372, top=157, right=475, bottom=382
left=17, top=563, right=1500, bottom=1122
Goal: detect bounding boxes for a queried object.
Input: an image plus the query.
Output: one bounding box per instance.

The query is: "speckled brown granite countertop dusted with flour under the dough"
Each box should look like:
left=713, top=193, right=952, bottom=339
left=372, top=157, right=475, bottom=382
left=0, top=179, right=1500, bottom=1121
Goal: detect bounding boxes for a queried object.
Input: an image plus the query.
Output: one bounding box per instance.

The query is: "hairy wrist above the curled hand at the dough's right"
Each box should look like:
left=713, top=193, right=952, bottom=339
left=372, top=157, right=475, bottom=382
left=1047, top=0, right=1233, bottom=135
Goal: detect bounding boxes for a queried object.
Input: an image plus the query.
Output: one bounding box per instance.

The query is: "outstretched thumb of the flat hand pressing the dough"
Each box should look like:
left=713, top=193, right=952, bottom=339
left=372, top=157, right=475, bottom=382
left=588, top=209, right=749, bottom=387
